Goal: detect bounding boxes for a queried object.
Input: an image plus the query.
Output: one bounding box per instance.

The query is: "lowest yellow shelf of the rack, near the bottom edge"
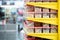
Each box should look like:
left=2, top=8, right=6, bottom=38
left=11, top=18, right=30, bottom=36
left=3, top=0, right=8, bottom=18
left=28, top=33, right=57, bottom=40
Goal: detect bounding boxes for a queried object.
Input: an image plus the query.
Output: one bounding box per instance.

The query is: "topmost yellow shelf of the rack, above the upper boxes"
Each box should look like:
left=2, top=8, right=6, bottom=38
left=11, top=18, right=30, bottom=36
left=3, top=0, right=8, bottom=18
left=26, top=2, right=58, bottom=10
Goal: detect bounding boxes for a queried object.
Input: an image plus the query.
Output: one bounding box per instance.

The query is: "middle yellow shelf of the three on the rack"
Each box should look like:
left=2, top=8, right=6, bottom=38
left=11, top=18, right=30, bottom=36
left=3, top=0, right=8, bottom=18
left=27, top=17, right=58, bottom=25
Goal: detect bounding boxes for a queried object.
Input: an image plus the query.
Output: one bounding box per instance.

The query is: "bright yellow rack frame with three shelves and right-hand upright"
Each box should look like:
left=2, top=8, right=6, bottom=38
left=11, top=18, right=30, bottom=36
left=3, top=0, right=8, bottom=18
left=24, top=0, right=60, bottom=40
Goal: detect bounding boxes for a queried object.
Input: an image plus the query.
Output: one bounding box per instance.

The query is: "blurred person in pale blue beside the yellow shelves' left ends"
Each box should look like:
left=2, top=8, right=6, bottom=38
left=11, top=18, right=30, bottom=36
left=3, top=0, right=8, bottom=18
left=17, top=9, right=25, bottom=40
